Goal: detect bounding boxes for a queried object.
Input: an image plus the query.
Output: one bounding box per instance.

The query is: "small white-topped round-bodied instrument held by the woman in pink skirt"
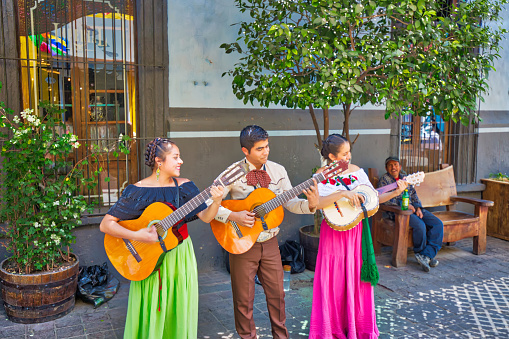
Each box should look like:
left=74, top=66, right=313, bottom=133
left=323, top=172, right=424, bottom=231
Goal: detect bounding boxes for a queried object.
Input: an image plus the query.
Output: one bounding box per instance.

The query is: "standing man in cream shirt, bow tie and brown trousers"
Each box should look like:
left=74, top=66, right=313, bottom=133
left=211, top=125, right=319, bottom=339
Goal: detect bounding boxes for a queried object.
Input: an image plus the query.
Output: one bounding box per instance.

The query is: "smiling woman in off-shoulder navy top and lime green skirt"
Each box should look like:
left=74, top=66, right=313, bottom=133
left=100, top=138, right=223, bottom=339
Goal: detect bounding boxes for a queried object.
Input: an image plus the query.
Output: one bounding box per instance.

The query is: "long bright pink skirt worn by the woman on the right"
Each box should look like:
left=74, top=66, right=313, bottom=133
left=309, top=220, right=379, bottom=339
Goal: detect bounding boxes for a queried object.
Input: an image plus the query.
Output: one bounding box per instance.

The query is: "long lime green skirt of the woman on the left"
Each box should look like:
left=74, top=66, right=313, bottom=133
left=124, top=237, right=198, bottom=339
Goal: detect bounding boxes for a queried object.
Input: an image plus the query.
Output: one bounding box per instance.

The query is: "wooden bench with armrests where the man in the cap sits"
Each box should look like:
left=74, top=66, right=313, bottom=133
left=369, top=166, right=493, bottom=267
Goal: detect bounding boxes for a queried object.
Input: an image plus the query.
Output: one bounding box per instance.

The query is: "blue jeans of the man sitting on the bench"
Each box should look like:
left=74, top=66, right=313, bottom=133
left=409, top=208, right=444, bottom=258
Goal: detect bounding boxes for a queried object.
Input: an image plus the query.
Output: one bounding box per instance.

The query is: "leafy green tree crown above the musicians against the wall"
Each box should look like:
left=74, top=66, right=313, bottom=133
left=221, top=0, right=508, bottom=148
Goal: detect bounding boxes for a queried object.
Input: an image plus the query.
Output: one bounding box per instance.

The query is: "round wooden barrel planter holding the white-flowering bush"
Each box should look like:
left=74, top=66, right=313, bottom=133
left=0, top=256, right=79, bottom=324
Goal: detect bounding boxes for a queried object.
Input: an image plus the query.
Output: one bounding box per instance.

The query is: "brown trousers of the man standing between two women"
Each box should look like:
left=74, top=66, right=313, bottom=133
left=230, top=237, right=288, bottom=339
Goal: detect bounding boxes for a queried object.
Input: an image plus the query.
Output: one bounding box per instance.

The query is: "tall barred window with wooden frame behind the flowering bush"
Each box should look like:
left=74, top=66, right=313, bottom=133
left=0, top=0, right=169, bottom=214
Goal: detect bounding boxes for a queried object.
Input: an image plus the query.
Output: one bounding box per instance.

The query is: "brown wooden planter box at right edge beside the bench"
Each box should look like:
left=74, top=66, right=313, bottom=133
left=481, top=172, right=509, bottom=240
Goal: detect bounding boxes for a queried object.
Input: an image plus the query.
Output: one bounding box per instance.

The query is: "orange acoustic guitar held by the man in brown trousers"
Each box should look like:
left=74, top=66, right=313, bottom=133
left=210, top=161, right=348, bottom=254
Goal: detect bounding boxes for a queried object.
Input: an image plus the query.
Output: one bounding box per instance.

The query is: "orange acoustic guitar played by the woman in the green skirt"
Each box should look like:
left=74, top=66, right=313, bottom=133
left=104, top=163, right=249, bottom=281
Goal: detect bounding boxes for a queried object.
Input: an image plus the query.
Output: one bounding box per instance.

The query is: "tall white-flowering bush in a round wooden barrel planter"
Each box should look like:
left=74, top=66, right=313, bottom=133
left=0, top=100, right=129, bottom=323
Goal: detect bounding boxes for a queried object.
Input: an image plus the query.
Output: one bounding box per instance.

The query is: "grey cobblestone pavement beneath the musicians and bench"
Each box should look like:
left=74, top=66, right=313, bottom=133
left=0, top=237, right=509, bottom=339
